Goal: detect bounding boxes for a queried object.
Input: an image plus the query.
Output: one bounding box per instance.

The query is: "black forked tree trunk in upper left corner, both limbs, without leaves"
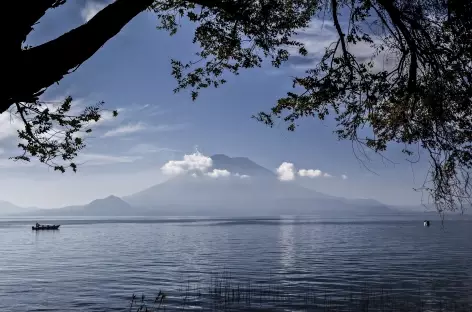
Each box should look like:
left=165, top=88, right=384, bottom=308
left=0, top=0, right=153, bottom=113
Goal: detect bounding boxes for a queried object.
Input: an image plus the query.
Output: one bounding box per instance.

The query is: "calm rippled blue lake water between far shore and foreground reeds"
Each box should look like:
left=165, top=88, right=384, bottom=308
left=0, top=215, right=472, bottom=311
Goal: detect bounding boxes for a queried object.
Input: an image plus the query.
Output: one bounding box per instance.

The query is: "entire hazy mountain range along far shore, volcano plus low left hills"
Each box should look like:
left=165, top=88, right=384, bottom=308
left=0, top=154, right=438, bottom=216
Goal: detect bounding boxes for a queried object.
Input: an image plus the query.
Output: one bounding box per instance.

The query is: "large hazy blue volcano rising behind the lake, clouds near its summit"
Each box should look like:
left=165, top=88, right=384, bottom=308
left=123, top=154, right=390, bottom=215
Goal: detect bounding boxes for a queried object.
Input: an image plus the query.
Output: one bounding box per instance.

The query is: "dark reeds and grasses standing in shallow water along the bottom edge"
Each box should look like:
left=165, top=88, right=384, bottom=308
left=128, top=275, right=472, bottom=312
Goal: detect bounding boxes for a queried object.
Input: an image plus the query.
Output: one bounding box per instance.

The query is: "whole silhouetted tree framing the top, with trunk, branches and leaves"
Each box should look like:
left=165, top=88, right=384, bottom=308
left=0, top=0, right=472, bottom=211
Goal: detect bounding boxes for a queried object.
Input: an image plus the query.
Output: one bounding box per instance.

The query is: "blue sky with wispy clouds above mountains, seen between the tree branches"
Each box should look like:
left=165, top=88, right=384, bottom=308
left=0, top=0, right=428, bottom=208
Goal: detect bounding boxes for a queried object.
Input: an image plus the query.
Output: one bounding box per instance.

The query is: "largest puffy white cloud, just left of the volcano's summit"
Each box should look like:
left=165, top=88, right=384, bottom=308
left=161, top=151, right=213, bottom=176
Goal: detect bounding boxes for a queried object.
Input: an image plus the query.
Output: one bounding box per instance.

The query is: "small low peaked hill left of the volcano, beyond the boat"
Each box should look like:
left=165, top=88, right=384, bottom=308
left=27, top=195, right=146, bottom=216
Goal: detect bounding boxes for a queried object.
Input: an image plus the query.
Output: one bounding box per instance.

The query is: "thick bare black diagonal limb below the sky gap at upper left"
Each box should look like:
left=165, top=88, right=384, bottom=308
left=4, top=0, right=153, bottom=113
